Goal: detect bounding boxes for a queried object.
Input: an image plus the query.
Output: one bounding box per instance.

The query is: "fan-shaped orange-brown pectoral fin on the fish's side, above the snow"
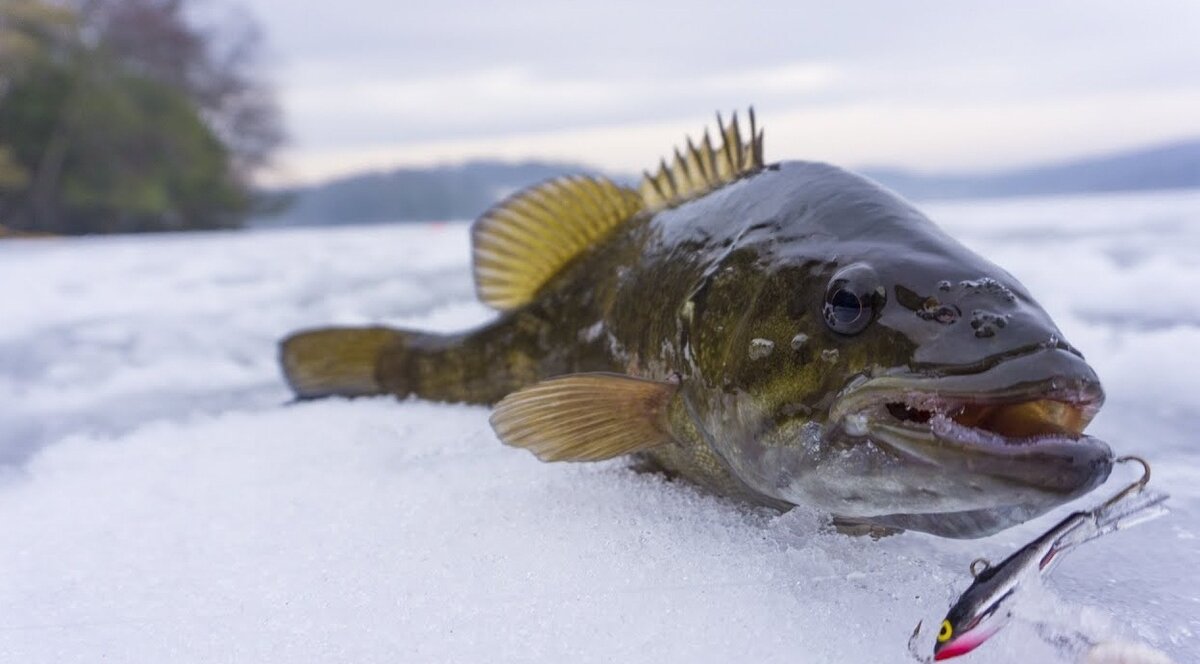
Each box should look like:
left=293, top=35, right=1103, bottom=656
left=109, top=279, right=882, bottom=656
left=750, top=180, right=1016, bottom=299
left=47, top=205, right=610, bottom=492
left=491, top=373, right=678, bottom=461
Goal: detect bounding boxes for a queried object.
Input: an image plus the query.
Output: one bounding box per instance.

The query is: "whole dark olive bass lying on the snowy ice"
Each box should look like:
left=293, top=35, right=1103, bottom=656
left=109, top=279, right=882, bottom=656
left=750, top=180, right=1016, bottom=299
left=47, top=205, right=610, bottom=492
left=280, top=108, right=1112, bottom=538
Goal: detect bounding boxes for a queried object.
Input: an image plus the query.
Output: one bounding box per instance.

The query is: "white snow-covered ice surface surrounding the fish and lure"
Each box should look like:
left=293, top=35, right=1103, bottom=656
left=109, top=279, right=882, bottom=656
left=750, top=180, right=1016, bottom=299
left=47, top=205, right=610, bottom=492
left=0, top=191, right=1200, bottom=663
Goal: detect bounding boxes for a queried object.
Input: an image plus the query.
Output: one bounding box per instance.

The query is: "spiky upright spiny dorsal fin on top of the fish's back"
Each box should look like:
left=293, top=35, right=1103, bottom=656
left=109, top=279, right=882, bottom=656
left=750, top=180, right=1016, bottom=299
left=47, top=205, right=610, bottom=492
left=638, top=107, right=763, bottom=210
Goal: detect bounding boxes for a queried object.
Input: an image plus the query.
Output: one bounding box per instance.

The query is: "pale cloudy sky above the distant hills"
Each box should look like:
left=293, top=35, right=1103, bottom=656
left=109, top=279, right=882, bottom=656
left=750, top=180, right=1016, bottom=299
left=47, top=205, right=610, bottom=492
left=234, top=0, right=1200, bottom=183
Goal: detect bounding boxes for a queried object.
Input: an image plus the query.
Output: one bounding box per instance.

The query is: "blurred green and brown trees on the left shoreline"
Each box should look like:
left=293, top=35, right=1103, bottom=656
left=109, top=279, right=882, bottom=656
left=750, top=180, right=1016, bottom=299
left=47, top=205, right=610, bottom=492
left=0, top=0, right=282, bottom=233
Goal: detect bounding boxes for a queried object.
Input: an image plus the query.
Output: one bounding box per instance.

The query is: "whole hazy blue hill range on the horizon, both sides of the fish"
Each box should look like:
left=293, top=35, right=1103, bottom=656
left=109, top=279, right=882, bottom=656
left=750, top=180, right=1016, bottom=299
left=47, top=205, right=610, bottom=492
left=256, top=138, right=1200, bottom=226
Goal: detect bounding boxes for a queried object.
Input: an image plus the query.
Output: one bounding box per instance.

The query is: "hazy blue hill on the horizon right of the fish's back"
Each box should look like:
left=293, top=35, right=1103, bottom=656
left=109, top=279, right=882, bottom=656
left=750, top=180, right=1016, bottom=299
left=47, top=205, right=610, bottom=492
left=858, top=138, right=1200, bottom=198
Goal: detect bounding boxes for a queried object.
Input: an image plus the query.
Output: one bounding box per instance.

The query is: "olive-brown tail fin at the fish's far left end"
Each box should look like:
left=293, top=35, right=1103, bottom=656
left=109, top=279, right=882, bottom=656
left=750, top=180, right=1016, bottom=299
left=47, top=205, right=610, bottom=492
left=280, top=328, right=404, bottom=399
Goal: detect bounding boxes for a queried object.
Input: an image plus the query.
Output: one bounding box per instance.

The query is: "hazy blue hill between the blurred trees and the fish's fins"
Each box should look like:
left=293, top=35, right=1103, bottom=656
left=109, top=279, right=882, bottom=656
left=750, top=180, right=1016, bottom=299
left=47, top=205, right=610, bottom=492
left=256, top=161, right=596, bottom=226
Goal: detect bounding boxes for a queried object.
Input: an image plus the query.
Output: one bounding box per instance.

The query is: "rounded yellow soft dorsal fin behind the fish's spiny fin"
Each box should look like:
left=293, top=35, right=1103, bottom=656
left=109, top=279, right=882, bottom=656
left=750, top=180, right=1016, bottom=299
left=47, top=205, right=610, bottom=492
left=470, top=175, right=643, bottom=311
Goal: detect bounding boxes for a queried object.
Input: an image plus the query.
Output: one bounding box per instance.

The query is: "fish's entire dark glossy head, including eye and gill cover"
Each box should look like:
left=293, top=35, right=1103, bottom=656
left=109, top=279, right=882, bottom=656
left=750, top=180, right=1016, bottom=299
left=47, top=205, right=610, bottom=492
left=681, top=163, right=1112, bottom=538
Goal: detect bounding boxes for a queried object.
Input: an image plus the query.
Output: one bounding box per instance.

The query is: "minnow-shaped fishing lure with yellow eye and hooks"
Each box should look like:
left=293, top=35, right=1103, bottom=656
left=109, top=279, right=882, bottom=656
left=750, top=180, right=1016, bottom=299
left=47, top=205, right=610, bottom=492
left=910, top=456, right=1168, bottom=662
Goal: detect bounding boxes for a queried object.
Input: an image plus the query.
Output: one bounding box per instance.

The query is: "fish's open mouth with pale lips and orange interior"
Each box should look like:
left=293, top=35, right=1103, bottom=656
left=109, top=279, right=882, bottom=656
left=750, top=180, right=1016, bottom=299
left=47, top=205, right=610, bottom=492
left=830, top=349, right=1112, bottom=497
